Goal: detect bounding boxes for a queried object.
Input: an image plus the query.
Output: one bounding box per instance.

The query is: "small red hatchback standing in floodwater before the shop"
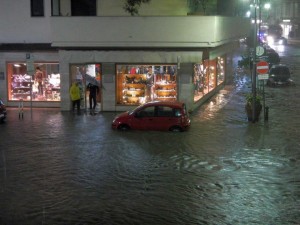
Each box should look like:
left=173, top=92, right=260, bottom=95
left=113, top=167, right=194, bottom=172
left=112, top=101, right=191, bottom=131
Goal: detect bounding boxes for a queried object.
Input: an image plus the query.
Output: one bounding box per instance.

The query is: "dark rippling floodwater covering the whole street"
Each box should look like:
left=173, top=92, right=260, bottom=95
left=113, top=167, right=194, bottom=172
left=0, top=44, right=300, bottom=225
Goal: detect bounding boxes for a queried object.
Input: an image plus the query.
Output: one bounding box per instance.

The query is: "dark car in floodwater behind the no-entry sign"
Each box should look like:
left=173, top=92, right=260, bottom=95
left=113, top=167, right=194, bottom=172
left=267, top=64, right=294, bottom=87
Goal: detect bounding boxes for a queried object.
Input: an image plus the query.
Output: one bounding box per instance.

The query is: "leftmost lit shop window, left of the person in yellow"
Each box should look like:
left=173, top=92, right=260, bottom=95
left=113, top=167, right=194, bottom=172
left=7, top=62, right=60, bottom=101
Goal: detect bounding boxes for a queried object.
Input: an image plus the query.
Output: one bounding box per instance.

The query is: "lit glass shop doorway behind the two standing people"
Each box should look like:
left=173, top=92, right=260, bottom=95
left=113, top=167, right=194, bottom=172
left=70, top=64, right=102, bottom=109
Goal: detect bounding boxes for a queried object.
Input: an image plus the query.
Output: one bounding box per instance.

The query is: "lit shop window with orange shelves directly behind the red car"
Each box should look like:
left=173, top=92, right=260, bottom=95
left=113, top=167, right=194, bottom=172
left=116, top=65, right=177, bottom=105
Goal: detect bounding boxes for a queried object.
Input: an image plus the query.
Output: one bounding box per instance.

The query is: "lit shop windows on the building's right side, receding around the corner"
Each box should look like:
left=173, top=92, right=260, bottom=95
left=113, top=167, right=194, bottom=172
left=193, top=57, right=225, bottom=102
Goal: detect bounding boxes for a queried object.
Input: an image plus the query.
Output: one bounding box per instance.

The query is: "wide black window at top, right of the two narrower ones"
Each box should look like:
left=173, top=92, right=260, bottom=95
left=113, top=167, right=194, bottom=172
left=71, top=0, right=97, bottom=16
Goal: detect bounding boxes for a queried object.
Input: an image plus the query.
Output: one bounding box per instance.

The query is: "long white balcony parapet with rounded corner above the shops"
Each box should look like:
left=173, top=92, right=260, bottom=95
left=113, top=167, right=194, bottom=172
left=50, top=16, right=250, bottom=48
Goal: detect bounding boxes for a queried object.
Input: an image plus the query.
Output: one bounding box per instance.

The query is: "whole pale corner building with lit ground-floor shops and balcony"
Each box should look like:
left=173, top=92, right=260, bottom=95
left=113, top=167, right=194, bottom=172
left=0, top=0, right=250, bottom=111
